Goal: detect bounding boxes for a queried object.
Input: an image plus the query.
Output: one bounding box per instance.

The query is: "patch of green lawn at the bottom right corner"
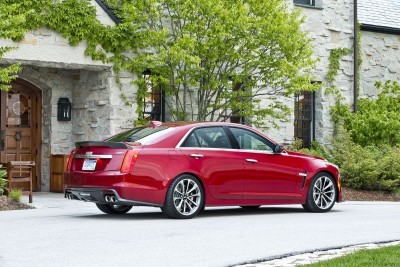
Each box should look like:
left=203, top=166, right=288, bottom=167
left=304, top=245, right=400, bottom=267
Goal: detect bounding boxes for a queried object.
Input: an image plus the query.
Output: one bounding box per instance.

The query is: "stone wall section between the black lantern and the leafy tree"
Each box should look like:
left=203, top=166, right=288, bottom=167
left=71, top=69, right=136, bottom=143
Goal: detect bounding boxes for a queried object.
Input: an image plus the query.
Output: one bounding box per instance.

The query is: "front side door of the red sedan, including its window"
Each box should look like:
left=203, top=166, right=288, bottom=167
left=230, top=127, right=302, bottom=199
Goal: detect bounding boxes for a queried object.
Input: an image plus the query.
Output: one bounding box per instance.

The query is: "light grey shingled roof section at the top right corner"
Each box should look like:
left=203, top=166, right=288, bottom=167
left=357, top=0, right=400, bottom=34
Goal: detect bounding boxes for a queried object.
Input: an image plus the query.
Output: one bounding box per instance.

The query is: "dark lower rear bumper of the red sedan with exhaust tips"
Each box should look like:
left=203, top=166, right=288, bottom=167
left=64, top=186, right=162, bottom=207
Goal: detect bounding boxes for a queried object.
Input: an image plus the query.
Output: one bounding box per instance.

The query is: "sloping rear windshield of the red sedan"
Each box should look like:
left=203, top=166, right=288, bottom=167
left=106, top=126, right=168, bottom=142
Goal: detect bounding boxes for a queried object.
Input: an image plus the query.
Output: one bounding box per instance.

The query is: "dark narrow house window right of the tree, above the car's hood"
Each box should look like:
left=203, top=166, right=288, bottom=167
left=294, top=92, right=315, bottom=147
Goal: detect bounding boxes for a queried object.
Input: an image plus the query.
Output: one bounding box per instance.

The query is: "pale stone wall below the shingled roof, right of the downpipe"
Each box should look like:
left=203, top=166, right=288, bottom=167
left=360, top=31, right=400, bottom=97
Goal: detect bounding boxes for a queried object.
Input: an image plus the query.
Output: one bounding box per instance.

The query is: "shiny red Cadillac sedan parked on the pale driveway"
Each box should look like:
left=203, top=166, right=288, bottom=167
left=64, top=122, right=342, bottom=219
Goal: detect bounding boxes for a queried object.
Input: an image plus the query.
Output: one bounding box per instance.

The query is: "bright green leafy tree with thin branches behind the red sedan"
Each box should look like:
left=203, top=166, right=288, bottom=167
left=109, top=0, right=316, bottom=123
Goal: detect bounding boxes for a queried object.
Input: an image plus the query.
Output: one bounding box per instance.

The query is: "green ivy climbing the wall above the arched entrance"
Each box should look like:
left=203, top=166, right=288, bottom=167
left=0, top=0, right=130, bottom=81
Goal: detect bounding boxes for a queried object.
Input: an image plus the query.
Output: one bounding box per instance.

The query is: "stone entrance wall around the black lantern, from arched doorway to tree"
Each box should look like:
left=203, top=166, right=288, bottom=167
left=15, top=64, right=136, bottom=191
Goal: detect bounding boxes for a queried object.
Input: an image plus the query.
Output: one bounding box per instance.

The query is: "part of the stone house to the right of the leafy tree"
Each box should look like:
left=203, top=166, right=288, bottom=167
left=275, top=0, right=400, bottom=147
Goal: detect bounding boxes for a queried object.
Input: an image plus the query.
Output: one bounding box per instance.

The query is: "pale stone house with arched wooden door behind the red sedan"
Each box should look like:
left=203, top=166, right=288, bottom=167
left=0, top=0, right=400, bottom=191
